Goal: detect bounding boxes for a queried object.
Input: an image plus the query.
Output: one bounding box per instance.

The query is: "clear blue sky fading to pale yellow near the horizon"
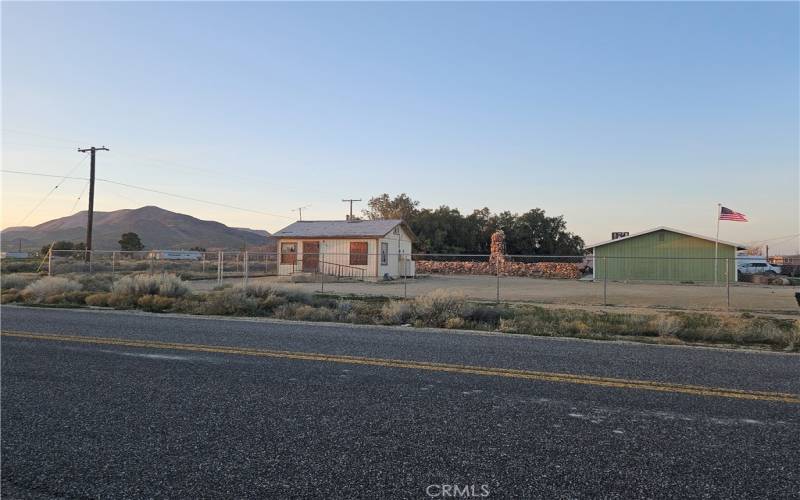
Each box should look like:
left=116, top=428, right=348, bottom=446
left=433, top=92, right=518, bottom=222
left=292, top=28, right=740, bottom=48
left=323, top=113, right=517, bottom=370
left=1, top=2, right=800, bottom=253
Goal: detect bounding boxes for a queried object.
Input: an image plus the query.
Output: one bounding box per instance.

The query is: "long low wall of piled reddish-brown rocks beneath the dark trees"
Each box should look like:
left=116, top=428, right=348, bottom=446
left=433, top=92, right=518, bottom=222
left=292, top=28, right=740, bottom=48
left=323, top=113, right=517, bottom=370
left=416, top=260, right=581, bottom=279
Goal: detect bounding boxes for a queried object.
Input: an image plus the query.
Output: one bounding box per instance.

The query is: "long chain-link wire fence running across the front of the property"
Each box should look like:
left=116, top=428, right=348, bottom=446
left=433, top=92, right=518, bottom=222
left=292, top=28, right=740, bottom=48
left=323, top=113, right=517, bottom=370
left=3, top=250, right=800, bottom=312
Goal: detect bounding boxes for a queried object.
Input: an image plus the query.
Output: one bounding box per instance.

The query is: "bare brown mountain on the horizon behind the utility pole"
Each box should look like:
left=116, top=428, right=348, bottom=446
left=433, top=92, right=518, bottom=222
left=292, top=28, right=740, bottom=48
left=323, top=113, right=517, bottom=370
left=0, top=206, right=274, bottom=250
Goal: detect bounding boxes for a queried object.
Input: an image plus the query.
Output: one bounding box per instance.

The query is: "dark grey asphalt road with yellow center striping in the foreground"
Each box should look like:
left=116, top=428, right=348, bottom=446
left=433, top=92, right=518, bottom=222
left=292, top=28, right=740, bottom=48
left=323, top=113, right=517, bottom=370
left=0, top=307, right=800, bottom=498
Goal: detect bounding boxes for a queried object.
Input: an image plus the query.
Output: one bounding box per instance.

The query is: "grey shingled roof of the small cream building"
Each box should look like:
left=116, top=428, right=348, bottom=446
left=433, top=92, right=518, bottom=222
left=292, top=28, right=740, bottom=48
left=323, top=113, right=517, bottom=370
left=273, top=219, right=414, bottom=239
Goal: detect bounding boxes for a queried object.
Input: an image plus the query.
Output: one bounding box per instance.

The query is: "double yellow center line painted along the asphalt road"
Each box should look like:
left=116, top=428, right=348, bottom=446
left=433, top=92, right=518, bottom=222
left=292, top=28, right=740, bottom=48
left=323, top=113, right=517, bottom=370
left=6, top=331, right=800, bottom=404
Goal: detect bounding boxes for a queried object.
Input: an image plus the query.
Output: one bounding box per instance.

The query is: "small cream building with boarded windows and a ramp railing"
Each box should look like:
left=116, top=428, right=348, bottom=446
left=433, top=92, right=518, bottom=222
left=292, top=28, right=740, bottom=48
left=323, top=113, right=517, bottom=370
left=273, top=219, right=415, bottom=279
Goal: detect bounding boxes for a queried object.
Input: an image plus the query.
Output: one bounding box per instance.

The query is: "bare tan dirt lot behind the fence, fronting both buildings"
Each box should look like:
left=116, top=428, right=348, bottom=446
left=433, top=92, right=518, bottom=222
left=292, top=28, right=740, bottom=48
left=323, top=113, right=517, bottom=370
left=192, top=275, right=800, bottom=314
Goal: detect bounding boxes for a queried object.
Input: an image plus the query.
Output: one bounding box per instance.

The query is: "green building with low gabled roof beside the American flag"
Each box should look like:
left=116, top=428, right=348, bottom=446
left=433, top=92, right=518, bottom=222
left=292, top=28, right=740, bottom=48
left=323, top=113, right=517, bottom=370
left=587, top=226, right=744, bottom=283
